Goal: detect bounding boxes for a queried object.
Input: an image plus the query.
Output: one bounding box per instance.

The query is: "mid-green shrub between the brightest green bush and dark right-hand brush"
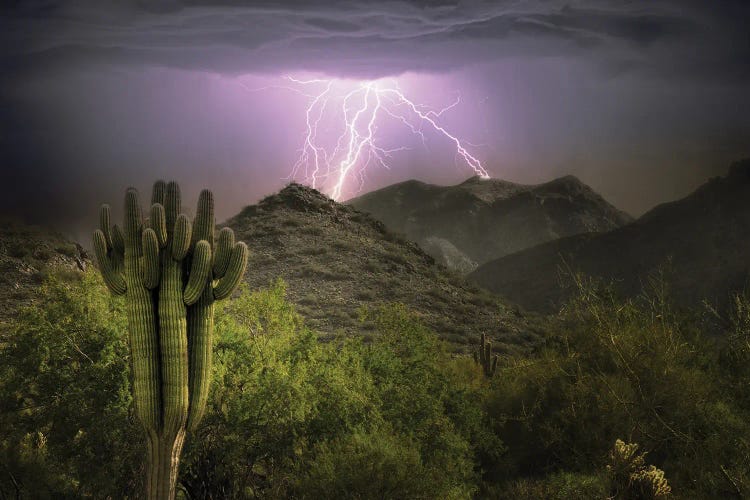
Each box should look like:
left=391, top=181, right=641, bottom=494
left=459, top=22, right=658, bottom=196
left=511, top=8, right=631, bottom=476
left=352, top=304, right=502, bottom=498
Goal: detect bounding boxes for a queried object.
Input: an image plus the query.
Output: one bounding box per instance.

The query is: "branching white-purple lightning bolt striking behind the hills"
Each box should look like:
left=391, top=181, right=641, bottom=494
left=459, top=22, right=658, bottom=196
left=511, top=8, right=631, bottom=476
left=250, top=76, right=490, bottom=200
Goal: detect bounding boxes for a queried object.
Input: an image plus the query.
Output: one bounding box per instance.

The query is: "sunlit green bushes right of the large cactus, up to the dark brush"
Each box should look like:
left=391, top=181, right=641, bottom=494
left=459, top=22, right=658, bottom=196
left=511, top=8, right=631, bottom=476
left=182, top=294, right=494, bottom=498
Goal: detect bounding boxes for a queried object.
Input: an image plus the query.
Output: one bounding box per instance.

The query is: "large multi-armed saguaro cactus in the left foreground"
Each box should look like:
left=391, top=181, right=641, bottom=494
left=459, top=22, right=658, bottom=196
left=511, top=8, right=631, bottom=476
left=94, top=181, right=248, bottom=499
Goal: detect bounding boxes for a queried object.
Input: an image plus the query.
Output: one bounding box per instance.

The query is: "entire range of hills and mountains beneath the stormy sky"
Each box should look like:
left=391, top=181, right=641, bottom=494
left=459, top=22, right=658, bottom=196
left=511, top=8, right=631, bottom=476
left=8, top=160, right=750, bottom=342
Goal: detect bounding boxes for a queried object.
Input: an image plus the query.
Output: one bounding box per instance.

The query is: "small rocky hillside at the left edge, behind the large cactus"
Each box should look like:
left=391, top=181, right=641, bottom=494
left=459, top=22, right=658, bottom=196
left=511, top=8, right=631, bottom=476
left=0, top=218, right=90, bottom=324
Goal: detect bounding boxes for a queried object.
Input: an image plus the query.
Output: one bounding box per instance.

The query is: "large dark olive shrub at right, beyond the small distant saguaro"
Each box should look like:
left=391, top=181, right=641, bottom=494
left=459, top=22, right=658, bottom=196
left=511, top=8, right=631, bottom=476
left=489, top=276, right=750, bottom=497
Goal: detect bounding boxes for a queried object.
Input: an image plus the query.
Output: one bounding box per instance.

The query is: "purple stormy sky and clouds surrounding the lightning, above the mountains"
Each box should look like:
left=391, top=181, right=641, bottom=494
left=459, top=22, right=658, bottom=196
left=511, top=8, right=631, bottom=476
left=0, top=0, right=750, bottom=238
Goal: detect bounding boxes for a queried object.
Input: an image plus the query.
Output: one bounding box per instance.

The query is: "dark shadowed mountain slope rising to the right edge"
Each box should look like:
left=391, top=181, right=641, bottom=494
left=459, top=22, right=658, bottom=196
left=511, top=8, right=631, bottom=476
left=469, top=159, right=750, bottom=312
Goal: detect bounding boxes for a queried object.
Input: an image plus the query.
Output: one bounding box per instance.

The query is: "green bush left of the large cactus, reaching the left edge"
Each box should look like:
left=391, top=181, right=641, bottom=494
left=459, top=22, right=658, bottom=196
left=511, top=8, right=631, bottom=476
left=0, top=271, right=143, bottom=498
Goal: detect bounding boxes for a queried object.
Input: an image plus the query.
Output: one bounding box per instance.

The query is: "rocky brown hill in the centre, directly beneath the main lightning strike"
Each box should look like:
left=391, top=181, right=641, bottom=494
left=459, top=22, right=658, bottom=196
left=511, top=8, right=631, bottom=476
left=225, top=183, right=536, bottom=356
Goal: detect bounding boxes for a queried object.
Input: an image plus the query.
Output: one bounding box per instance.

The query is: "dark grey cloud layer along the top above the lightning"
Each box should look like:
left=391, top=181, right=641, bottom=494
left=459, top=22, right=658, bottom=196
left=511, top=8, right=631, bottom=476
left=0, top=0, right=750, bottom=79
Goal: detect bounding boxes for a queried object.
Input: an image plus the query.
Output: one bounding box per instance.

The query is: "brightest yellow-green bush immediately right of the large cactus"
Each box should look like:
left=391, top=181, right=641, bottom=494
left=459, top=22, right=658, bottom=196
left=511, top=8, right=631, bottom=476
left=182, top=282, right=372, bottom=498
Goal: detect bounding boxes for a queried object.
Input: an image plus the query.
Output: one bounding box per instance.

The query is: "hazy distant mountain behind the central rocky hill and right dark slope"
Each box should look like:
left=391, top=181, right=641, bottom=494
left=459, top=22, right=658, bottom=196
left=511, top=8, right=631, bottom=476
left=348, top=176, right=632, bottom=273
